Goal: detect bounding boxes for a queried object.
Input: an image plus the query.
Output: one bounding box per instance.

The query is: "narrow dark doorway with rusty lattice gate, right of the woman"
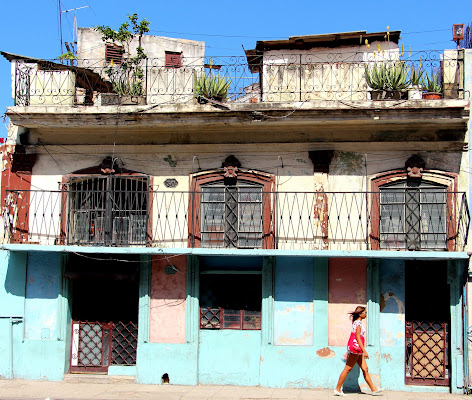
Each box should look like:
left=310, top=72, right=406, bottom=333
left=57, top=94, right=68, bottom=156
left=405, top=260, right=451, bottom=386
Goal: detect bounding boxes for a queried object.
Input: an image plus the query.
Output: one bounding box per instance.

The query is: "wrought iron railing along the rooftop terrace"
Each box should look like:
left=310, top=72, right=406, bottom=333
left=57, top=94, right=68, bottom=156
left=10, top=50, right=464, bottom=106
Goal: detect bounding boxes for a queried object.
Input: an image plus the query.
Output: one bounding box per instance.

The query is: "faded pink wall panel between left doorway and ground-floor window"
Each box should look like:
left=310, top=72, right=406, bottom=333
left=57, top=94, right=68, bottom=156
left=149, top=256, right=187, bottom=343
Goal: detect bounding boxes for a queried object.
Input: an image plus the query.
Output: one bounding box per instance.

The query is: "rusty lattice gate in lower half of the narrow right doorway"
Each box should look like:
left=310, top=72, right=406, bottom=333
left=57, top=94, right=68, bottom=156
left=405, top=321, right=449, bottom=386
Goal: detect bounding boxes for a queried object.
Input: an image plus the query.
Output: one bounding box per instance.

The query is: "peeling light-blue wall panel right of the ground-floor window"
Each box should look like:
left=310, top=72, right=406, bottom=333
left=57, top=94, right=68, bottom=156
left=274, top=257, right=313, bottom=346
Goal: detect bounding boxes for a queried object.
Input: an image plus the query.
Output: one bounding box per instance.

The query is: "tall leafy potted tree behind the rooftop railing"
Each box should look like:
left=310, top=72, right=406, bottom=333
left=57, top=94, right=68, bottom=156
left=95, top=14, right=150, bottom=105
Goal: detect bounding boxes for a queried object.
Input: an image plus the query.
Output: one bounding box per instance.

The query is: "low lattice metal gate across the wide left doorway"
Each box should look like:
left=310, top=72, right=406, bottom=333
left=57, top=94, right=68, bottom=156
left=70, top=321, right=138, bottom=372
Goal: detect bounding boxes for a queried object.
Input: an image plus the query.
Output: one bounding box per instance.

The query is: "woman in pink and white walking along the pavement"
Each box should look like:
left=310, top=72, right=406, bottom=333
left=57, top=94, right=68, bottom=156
left=334, top=306, right=384, bottom=396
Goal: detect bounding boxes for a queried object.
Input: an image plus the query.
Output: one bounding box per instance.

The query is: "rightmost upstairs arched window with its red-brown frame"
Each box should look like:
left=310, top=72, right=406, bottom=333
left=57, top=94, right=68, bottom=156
left=371, top=170, right=461, bottom=250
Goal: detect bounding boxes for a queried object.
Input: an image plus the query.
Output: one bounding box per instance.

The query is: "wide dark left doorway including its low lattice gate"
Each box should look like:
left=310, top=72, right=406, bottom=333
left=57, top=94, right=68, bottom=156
left=65, top=254, right=140, bottom=373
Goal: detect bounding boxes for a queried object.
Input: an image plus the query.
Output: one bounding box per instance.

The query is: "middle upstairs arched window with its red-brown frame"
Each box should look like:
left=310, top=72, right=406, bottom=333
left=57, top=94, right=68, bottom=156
left=189, top=170, right=274, bottom=249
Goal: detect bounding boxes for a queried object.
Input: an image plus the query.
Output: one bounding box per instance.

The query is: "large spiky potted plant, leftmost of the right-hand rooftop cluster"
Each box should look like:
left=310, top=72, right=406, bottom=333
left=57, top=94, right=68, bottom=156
left=365, top=61, right=409, bottom=100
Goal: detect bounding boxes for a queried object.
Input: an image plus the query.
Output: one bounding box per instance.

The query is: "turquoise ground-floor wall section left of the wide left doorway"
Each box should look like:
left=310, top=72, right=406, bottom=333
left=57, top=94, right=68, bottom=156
left=0, top=251, right=66, bottom=380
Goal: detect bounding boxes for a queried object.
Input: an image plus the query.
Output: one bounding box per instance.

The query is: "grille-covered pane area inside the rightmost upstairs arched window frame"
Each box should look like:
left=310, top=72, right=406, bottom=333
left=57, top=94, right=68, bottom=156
left=380, top=183, right=448, bottom=250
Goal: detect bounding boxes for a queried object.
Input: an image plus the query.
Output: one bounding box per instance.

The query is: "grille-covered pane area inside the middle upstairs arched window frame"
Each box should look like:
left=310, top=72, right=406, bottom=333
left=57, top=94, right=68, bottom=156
left=200, top=184, right=263, bottom=248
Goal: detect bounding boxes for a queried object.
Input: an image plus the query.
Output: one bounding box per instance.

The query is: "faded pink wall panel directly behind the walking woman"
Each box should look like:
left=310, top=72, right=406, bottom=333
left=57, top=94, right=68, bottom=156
left=328, top=258, right=367, bottom=346
